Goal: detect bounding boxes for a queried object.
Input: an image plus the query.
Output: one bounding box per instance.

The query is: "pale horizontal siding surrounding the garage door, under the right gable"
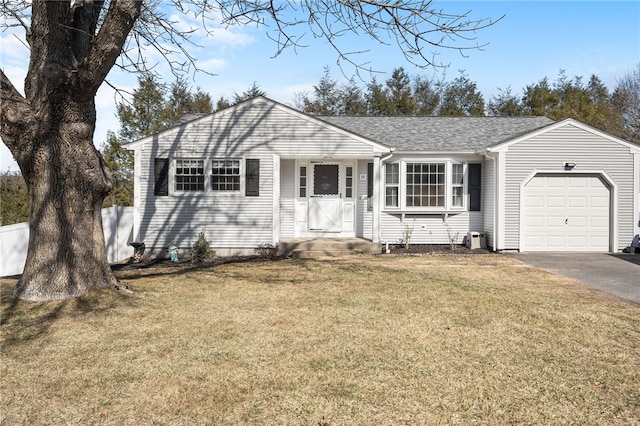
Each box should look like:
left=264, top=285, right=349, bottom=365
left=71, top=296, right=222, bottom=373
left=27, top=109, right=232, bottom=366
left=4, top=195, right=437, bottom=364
left=502, top=121, right=638, bottom=251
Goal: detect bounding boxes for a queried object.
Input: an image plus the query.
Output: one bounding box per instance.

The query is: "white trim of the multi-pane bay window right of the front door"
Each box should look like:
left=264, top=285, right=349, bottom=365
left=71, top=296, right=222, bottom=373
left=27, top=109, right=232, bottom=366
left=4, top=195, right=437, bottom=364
left=382, top=158, right=469, bottom=213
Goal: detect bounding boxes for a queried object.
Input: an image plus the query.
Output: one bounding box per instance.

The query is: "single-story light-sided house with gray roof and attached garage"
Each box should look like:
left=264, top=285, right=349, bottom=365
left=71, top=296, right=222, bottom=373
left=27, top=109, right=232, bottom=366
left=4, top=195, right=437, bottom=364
left=128, top=97, right=640, bottom=254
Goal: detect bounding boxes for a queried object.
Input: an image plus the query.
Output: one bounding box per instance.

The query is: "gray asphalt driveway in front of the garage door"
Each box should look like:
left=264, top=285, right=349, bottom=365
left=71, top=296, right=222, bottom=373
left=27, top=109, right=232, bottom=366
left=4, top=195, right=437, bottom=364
left=510, top=253, right=640, bottom=304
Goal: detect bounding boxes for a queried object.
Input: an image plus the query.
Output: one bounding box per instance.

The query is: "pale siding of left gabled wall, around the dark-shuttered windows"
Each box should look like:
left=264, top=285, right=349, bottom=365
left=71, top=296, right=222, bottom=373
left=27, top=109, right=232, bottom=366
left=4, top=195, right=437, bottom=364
left=135, top=100, right=384, bottom=251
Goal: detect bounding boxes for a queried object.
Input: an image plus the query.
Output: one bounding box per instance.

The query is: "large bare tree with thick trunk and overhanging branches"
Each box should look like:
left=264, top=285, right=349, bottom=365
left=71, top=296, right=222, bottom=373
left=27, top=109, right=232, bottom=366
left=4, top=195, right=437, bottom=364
left=0, top=0, right=500, bottom=301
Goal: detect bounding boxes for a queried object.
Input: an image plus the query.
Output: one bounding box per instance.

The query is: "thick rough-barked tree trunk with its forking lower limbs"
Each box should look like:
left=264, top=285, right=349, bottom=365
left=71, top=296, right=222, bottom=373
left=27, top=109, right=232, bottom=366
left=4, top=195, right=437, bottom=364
left=0, top=0, right=142, bottom=301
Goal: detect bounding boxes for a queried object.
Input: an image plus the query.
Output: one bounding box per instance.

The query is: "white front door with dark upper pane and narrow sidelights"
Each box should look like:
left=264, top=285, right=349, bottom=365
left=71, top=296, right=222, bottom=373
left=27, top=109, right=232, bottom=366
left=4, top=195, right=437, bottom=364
left=296, top=161, right=355, bottom=237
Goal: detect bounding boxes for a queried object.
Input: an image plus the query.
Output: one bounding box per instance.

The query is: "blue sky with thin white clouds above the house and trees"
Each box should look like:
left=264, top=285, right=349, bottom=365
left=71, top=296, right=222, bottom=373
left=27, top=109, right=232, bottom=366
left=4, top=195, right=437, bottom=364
left=0, top=0, right=640, bottom=172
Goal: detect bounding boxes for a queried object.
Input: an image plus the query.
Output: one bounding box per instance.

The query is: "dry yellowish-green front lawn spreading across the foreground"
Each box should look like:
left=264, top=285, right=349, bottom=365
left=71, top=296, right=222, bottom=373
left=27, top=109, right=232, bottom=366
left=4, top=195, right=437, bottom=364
left=0, top=255, right=640, bottom=425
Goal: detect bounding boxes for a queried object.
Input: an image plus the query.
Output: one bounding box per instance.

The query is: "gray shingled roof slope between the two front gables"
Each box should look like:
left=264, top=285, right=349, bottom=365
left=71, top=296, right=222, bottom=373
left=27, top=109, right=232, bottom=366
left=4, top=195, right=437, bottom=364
left=317, top=116, right=553, bottom=152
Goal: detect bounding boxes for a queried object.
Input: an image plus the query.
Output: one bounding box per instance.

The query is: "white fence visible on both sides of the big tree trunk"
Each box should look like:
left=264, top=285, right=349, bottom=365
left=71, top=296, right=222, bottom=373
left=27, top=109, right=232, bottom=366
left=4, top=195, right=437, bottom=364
left=0, top=206, right=133, bottom=277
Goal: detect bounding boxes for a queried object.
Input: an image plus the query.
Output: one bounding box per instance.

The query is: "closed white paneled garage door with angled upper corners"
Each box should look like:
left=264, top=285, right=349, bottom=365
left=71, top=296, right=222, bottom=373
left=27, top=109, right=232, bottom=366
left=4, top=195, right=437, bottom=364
left=521, top=175, right=610, bottom=252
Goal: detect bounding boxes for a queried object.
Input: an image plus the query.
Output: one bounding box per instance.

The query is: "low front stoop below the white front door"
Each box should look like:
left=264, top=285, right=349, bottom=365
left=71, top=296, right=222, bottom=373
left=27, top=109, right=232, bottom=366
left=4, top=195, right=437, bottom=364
left=280, top=238, right=382, bottom=259
